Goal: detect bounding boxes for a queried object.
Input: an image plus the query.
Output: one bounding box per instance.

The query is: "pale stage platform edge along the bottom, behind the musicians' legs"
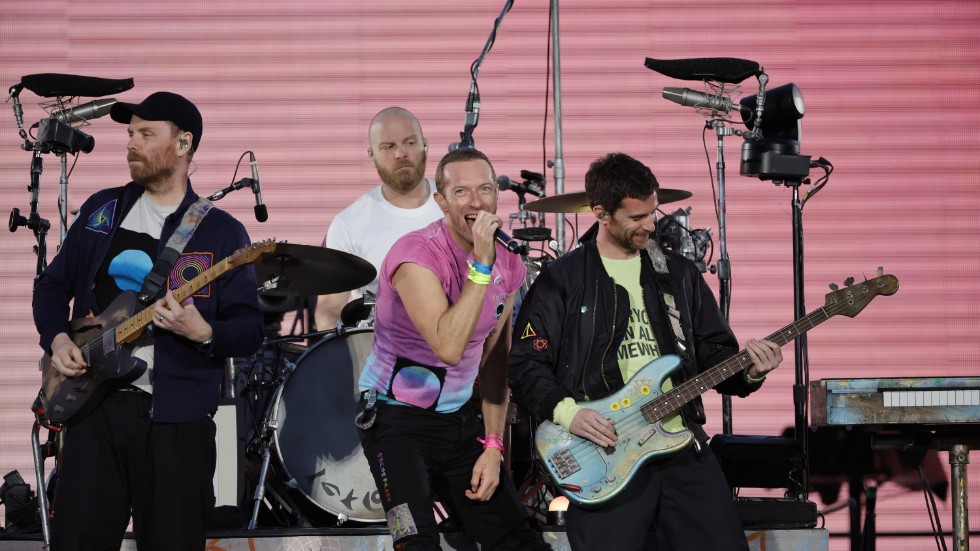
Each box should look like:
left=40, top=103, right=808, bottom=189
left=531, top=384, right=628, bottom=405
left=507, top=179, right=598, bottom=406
left=0, top=527, right=830, bottom=551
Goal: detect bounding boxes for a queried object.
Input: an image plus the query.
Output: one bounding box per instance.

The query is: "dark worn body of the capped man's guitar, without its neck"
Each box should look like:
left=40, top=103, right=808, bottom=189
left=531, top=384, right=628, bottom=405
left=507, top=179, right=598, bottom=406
left=40, top=291, right=149, bottom=424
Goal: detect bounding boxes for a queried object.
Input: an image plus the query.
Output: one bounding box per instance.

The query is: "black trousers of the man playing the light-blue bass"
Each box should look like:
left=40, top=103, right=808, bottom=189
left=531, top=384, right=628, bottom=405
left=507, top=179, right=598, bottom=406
left=565, top=445, right=749, bottom=551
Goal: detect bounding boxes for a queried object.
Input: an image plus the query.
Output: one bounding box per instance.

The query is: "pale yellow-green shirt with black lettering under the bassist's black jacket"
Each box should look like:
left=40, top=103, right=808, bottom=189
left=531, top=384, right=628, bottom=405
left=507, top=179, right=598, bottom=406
left=553, top=255, right=684, bottom=432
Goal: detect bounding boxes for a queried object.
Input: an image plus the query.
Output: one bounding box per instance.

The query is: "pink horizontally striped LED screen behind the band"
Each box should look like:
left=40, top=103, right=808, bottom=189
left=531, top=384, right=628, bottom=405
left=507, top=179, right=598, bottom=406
left=0, top=0, right=980, bottom=549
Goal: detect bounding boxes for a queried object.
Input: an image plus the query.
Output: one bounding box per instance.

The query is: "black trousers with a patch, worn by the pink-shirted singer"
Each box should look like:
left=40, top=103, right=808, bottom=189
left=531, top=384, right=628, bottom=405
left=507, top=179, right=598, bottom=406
left=359, top=404, right=550, bottom=551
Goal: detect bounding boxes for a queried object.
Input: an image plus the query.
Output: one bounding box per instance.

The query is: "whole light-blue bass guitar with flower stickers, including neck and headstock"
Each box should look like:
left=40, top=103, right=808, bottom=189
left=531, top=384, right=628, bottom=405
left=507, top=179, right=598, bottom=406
left=534, top=271, right=898, bottom=507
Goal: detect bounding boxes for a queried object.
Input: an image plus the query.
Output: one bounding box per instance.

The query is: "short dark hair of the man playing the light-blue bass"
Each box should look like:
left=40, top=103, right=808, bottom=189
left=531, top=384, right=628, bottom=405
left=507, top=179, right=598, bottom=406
left=585, top=153, right=660, bottom=215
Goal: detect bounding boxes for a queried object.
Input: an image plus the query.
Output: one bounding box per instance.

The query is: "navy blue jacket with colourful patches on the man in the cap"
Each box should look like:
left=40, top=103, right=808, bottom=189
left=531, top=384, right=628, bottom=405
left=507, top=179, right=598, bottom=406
left=33, top=182, right=262, bottom=423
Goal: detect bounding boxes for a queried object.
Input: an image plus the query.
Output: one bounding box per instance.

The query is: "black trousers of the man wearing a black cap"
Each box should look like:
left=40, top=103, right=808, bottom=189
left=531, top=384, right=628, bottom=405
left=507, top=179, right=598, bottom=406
left=51, top=391, right=216, bottom=551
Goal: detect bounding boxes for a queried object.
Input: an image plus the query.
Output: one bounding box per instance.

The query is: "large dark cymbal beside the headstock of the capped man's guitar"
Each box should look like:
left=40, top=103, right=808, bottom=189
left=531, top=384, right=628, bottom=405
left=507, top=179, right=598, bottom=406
left=255, top=243, right=377, bottom=296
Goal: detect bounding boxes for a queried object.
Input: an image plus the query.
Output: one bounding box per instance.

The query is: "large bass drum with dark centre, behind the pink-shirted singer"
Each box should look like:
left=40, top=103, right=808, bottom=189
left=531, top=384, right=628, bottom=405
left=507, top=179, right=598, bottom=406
left=267, top=329, right=385, bottom=522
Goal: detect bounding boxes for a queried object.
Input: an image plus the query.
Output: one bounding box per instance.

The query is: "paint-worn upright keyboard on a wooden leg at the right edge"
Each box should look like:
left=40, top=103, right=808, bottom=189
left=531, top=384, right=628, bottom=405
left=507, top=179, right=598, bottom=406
left=809, top=377, right=980, bottom=551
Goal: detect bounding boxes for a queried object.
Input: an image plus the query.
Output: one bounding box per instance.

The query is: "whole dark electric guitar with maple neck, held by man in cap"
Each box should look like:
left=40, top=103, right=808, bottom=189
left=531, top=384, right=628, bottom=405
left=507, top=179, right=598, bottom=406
left=38, top=239, right=276, bottom=424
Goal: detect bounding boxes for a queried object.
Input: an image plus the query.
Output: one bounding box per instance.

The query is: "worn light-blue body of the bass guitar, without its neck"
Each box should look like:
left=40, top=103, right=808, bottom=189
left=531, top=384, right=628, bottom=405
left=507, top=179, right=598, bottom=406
left=534, top=355, right=694, bottom=507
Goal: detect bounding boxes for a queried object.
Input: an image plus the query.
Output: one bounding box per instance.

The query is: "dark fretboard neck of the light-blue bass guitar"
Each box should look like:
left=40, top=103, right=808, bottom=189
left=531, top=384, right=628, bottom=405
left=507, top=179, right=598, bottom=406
left=642, top=307, right=831, bottom=421
